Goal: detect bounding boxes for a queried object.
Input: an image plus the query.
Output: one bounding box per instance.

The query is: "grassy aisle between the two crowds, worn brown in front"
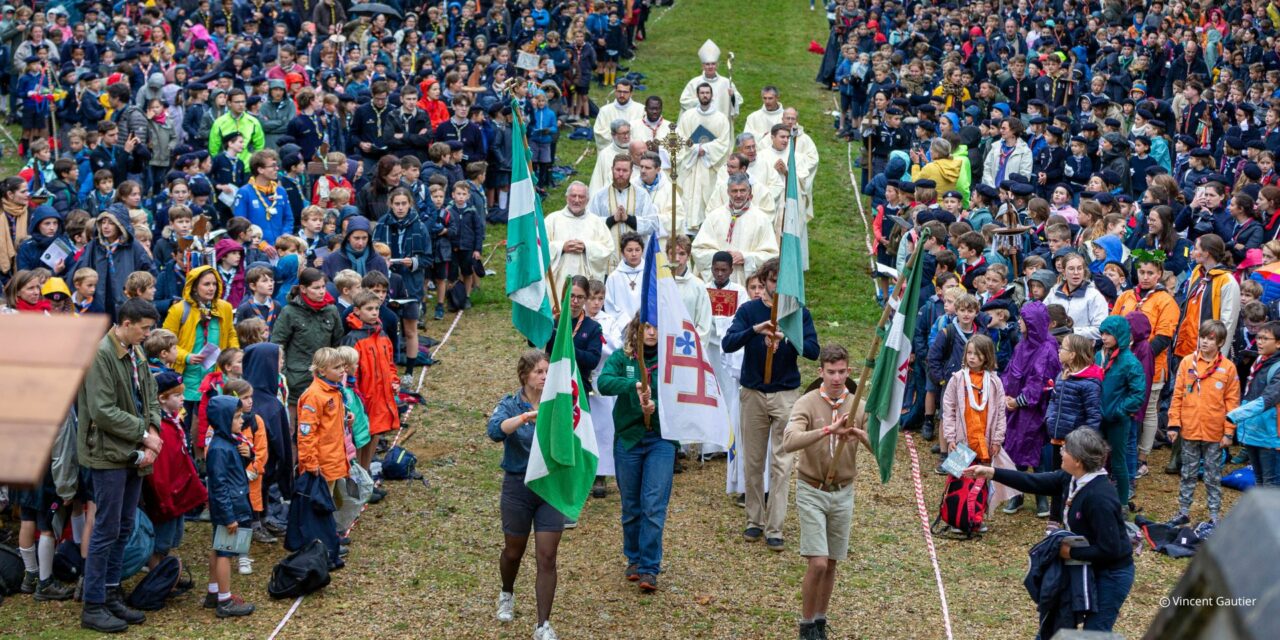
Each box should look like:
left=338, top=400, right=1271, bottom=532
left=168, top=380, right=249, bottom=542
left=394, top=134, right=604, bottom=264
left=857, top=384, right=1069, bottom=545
left=0, top=0, right=1218, bottom=639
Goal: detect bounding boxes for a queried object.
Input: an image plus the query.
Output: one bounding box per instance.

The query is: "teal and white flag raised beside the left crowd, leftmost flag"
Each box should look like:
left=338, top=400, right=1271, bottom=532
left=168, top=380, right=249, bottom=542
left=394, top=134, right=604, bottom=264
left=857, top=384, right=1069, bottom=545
left=507, top=102, right=555, bottom=347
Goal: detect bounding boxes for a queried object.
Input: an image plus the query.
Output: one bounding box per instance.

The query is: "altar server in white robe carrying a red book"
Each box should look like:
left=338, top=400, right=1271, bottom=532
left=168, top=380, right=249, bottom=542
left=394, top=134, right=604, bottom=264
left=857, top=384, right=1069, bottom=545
left=703, top=251, right=750, bottom=483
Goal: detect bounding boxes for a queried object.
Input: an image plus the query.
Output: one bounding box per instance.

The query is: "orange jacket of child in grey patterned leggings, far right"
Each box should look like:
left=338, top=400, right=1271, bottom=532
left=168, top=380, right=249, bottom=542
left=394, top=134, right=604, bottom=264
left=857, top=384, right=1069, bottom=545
left=1169, top=352, right=1240, bottom=442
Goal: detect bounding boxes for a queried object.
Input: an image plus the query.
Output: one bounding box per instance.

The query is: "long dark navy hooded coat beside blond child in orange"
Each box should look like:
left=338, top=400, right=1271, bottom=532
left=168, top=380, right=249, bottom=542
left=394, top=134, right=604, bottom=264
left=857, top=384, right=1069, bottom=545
left=244, top=342, right=297, bottom=495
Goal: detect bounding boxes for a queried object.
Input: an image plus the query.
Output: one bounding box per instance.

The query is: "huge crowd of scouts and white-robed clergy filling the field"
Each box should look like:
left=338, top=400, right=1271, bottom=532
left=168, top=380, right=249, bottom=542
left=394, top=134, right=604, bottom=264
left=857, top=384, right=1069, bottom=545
left=0, top=0, right=1280, bottom=640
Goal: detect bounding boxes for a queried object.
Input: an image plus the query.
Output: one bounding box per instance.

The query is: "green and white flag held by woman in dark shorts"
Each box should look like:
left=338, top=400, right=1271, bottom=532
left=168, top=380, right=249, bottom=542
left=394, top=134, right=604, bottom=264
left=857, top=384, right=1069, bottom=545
left=525, top=284, right=600, bottom=520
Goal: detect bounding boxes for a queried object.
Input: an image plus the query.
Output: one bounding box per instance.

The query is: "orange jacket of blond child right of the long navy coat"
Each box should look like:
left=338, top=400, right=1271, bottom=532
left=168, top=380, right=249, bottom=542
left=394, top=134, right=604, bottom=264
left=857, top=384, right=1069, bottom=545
left=298, top=378, right=348, bottom=483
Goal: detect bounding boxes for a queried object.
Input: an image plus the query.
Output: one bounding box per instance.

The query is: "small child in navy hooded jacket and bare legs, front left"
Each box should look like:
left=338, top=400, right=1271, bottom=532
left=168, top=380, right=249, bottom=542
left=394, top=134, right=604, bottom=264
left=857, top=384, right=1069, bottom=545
left=205, top=396, right=253, bottom=618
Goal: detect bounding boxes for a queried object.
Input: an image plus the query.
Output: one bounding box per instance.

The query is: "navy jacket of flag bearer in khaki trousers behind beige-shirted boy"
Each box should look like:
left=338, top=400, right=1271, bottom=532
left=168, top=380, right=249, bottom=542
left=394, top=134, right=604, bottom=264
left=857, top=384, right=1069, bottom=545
left=721, top=300, right=819, bottom=393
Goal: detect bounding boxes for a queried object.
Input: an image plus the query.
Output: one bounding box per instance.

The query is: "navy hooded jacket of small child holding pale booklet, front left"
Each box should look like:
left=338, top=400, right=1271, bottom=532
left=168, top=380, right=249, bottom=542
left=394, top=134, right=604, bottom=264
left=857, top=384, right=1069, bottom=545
left=205, top=396, right=253, bottom=525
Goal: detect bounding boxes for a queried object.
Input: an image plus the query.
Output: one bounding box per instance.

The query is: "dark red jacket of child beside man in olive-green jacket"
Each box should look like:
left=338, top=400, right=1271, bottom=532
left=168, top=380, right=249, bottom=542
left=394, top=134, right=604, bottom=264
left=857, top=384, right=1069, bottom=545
left=142, top=415, right=209, bottom=524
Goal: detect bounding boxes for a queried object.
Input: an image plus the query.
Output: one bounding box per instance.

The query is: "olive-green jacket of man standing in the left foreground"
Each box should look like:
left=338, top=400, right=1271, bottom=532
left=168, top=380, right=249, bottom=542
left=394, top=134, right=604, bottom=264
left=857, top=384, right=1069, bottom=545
left=76, top=330, right=160, bottom=475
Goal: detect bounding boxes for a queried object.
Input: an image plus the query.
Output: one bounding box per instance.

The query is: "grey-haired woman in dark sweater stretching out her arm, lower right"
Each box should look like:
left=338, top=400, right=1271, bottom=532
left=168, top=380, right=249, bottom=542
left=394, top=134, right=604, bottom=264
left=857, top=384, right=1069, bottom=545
left=964, top=427, right=1134, bottom=631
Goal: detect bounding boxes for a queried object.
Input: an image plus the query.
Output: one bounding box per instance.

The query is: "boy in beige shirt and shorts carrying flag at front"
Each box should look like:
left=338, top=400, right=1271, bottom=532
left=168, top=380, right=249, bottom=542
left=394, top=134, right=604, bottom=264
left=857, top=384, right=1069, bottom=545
left=782, top=344, right=870, bottom=640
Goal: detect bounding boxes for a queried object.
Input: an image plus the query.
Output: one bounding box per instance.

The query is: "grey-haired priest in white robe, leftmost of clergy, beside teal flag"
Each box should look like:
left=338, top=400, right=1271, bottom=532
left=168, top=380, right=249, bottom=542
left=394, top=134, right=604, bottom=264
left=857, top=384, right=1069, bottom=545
left=545, top=180, right=614, bottom=283
